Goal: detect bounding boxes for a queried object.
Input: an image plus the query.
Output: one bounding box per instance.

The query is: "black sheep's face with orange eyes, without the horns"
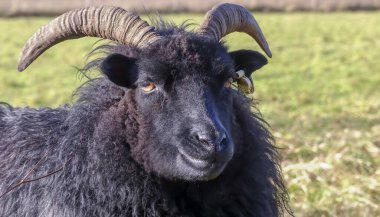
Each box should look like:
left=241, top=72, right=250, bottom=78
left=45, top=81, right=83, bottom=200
left=101, top=32, right=266, bottom=181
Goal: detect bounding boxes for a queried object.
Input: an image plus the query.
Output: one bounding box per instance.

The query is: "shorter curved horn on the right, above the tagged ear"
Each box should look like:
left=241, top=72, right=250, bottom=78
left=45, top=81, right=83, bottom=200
left=197, top=3, right=272, bottom=57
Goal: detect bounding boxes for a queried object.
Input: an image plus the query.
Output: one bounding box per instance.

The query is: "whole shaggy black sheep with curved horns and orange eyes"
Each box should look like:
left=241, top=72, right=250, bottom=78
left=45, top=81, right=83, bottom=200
left=0, top=4, right=288, bottom=217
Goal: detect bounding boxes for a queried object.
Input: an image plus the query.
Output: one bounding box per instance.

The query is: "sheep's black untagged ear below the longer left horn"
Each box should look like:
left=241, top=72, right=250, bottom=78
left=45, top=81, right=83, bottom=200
left=100, top=54, right=138, bottom=88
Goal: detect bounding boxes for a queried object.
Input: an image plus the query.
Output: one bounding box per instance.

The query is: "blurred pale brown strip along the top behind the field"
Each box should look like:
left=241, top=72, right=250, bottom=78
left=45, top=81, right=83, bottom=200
left=0, top=0, right=380, bottom=16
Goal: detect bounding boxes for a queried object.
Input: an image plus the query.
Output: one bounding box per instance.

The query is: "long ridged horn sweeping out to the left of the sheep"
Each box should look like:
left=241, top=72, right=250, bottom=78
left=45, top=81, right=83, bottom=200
left=18, top=6, right=160, bottom=71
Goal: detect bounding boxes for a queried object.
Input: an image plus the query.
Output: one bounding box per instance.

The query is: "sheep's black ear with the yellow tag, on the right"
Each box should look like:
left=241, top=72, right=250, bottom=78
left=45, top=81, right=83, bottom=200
left=230, top=50, right=268, bottom=78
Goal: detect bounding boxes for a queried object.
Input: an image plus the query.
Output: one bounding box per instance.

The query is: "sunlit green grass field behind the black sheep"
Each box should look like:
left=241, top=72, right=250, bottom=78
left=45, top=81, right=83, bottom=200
left=0, top=12, right=380, bottom=217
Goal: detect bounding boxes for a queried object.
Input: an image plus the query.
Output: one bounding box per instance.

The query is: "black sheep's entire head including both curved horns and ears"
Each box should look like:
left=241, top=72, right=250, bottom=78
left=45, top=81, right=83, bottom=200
left=19, top=4, right=271, bottom=181
